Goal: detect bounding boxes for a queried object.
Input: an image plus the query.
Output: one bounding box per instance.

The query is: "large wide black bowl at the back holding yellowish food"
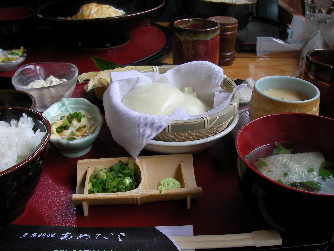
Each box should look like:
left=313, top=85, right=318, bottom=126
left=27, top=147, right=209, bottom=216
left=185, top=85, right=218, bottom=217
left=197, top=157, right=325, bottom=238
left=37, top=0, right=165, bottom=47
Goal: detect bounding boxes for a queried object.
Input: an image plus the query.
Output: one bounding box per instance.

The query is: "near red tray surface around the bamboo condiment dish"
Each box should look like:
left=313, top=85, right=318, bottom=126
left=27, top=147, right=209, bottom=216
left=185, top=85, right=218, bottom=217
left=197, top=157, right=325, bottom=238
left=10, top=84, right=266, bottom=234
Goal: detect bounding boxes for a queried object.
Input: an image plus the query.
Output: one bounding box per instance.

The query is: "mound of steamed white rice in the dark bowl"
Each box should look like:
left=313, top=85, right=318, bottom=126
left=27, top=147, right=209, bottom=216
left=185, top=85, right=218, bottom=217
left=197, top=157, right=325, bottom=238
left=0, top=113, right=45, bottom=172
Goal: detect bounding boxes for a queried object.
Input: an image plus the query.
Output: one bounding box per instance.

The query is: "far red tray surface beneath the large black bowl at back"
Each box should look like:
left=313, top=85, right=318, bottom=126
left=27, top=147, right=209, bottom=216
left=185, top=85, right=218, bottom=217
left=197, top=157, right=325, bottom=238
left=0, top=25, right=168, bottom=77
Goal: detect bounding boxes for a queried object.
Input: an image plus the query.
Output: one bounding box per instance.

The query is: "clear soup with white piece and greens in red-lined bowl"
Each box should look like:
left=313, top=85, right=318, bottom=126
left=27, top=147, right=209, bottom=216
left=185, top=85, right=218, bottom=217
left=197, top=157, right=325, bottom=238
left=246, top=142, right=334, bottom=195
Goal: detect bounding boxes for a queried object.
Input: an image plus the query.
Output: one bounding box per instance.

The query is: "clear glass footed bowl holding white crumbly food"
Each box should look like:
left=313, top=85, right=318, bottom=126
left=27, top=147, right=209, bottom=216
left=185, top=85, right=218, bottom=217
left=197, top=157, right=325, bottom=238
left=12, top=62, right=78, bottom=112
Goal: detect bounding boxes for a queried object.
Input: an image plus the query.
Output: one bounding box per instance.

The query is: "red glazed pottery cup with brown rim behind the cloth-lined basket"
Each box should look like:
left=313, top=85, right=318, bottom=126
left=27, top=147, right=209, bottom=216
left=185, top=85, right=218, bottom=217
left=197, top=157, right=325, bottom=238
left=171, top=18, right=220, bottom=65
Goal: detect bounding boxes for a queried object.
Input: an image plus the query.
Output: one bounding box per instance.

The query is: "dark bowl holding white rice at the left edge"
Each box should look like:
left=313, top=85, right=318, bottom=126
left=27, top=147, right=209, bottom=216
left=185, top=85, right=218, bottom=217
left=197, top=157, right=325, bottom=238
left=0, top=107, right=51, bottom=226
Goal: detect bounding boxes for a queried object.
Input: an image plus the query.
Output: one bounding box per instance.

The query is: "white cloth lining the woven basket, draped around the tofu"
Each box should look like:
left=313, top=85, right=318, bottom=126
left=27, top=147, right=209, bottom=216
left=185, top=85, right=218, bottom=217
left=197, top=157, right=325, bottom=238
left=103, top=61, right=243, bottom=158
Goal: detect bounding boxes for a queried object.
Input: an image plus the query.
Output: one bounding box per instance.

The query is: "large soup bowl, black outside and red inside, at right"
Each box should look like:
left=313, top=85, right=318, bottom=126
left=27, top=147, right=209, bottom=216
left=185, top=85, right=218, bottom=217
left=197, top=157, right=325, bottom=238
left=236, top=113, right=334, bottom=234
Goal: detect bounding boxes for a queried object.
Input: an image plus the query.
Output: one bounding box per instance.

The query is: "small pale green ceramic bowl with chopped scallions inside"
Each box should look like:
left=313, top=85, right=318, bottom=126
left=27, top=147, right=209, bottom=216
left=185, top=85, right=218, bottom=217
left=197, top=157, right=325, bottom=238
left=43, top=98, right=103, bottom=158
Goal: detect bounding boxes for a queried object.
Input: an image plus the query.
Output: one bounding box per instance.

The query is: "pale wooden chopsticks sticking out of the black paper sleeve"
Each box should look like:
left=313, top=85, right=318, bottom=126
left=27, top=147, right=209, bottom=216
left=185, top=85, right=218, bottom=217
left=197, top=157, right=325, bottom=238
left=171, top=230, right=282, bottom=249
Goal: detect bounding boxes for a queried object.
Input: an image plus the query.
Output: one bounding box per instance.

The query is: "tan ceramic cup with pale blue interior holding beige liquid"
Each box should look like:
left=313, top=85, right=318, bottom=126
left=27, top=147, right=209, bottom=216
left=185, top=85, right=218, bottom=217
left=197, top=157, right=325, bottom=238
left=249, top=76, right=320, bottom=120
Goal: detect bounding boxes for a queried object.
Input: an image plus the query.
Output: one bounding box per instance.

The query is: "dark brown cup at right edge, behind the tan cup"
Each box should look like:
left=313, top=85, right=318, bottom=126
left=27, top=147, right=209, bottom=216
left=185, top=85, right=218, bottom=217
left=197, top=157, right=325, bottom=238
left=303, top=49, right=334, bottom=118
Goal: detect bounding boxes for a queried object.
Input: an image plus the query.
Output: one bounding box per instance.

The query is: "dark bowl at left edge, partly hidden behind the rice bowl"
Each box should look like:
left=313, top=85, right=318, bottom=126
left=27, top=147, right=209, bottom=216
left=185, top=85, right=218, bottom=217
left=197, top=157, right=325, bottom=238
left=0, top=90, right=36, bottom=110
